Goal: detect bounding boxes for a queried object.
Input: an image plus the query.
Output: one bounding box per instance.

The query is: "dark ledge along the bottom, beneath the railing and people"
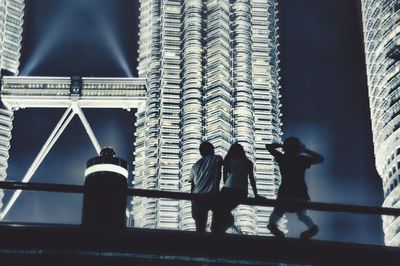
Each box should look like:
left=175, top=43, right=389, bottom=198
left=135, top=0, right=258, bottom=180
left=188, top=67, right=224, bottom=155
left=0, top=224, right=400, bottom=265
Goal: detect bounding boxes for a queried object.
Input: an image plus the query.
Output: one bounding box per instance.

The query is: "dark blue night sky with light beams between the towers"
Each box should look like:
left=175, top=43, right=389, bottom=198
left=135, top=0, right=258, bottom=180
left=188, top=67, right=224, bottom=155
left=6, top=0, right=383, bottom=244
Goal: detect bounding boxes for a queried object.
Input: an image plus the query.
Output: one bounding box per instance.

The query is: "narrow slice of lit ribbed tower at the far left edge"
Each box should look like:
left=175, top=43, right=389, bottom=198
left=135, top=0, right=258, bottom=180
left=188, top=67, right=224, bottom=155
left=0, top=0, right=25, bottom=208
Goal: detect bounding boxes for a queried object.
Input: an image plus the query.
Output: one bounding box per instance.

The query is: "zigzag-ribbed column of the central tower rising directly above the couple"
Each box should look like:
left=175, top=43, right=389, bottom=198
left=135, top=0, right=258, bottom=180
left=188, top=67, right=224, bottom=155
left=204, top=0, right=233, bottom=155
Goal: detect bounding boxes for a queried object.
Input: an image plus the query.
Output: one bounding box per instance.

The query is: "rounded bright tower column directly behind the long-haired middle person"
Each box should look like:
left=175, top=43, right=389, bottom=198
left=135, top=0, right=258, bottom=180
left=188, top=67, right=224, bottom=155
left=231, top=0, right=257, bottom=234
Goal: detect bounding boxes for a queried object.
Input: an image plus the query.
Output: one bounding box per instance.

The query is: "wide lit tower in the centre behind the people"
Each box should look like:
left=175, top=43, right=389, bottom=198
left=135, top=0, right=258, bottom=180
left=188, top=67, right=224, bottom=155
left=132, top=0, right=281, bottom=234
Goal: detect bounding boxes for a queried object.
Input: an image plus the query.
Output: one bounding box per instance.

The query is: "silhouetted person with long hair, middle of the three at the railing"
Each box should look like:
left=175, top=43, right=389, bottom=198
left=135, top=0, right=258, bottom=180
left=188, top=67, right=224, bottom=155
left=211, top=143, right=258, bottom=233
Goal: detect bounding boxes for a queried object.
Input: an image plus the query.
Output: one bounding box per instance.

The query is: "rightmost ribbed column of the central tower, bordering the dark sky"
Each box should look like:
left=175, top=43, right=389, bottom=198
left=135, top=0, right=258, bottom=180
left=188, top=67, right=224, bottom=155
left=252, top=0, right=286, bottom=235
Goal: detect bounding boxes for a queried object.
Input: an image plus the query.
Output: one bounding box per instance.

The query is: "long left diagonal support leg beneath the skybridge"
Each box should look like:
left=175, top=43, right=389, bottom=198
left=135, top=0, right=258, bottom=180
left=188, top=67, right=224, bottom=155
left=0, top=107, right=75, bottom=220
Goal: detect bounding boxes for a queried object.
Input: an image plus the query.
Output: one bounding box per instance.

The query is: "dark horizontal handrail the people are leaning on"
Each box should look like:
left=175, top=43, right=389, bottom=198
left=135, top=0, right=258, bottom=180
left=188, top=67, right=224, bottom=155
left=0, top=181, right=400, bottom=216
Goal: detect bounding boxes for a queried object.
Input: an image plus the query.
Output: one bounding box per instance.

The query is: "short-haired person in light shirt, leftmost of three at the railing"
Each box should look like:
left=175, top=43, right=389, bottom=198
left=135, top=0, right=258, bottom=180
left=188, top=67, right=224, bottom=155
left=189, top=141, right=223, bottom=232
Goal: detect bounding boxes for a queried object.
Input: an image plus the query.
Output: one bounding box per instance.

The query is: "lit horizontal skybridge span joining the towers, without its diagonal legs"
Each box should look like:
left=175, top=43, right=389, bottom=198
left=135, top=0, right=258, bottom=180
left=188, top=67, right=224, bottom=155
left=1, top=76, right=146, bottom=110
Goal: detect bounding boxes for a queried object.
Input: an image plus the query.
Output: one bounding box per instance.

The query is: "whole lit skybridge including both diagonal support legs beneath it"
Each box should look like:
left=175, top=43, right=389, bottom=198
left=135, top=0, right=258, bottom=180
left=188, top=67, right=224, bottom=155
left=0, top=76, right=146, bottom=220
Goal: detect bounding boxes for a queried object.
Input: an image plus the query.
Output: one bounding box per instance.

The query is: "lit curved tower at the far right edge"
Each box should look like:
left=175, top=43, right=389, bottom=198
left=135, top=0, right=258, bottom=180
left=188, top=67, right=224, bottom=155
left=362, top=0, right=400, bottom=246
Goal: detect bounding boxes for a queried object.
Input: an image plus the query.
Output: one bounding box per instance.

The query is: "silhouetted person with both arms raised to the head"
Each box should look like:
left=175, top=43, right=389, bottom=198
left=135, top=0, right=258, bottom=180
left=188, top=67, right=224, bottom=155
left=266, top=137, right=324, bottom=239
